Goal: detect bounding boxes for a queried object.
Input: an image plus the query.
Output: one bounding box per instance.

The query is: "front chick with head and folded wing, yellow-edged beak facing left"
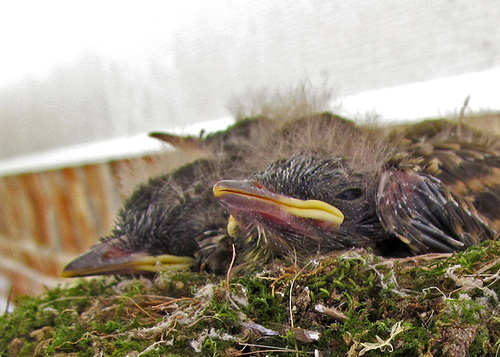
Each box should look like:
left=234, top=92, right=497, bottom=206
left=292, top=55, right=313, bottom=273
left=214, top=149, right=496, bottom=268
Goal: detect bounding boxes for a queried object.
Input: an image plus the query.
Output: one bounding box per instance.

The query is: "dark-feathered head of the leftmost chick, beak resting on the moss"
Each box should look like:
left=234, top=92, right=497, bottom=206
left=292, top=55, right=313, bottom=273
left=62, top=159, right=227, bottom=277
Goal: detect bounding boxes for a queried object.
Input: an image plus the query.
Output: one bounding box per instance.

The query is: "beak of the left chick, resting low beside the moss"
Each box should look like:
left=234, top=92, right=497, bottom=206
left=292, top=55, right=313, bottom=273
left=61, top=240, right=194, bottom=278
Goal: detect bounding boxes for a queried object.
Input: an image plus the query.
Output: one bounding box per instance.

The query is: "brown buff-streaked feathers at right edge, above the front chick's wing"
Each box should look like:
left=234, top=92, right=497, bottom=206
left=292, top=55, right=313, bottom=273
left=388, top=120, right=500, bottom=231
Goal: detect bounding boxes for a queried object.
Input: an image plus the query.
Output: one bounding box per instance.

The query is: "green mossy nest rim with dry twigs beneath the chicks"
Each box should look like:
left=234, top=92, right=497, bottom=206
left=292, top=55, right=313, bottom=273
left=0, top=241, right=500, bottom=356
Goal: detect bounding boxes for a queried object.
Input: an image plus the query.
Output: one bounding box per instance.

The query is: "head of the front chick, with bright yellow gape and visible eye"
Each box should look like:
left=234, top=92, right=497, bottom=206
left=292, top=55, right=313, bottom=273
left=214, top=153, right=385, bottom=261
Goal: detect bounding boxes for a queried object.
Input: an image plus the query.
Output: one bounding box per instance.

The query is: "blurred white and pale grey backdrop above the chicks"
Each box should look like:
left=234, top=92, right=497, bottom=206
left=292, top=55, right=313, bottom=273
left=0, top=0, right=500, bottom=174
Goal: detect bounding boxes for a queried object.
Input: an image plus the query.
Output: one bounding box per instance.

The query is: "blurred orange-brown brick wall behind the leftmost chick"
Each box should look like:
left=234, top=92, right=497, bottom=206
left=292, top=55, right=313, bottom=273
left=0, top=159, right=148, bottom=297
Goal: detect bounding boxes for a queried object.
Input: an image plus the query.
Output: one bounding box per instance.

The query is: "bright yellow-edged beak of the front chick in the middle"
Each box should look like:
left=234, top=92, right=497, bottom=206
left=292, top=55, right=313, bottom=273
left=213, top=180, right=344, bottom=235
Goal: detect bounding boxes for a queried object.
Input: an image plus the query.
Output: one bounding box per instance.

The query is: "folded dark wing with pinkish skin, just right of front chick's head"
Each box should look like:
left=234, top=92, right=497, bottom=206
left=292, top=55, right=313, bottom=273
left=376, top=168, right=494, bottom=254
